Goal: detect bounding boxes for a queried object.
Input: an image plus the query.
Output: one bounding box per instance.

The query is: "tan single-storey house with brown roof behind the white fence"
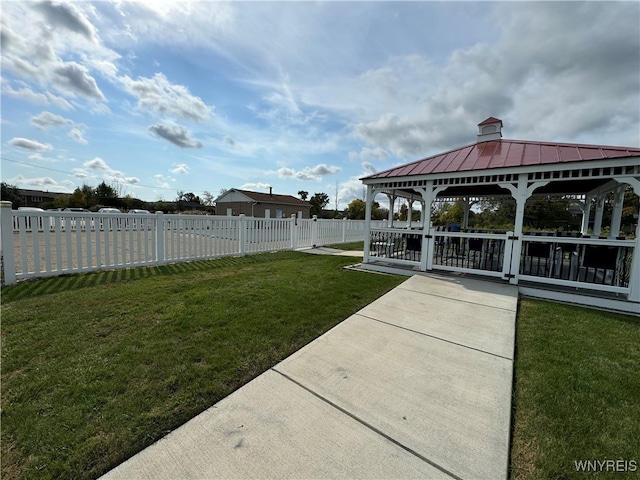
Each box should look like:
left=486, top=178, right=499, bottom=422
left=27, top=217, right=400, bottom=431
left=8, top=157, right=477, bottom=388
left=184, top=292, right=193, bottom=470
left=216, top=187, right=311, bottom=218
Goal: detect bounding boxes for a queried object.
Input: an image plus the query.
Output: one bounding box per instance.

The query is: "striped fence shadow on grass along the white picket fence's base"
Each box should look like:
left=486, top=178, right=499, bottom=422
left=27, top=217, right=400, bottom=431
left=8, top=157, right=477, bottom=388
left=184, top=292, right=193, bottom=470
left=2, top=251, right=306, bottom=303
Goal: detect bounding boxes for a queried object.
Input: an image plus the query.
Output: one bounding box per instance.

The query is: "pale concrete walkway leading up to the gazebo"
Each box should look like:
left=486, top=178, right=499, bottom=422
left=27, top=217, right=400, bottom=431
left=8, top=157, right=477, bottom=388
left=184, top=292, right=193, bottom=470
left=103, top=275, right=517, bottom=480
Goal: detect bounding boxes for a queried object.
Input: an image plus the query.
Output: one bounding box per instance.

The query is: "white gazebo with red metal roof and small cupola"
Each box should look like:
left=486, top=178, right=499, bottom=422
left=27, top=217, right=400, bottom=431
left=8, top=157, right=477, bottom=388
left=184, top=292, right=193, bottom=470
left=361, top=117, right=640, bottom=313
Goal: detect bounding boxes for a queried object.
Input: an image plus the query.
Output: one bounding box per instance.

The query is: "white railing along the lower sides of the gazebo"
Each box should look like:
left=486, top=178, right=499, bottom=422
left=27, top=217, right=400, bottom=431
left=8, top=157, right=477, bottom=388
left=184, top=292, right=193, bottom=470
left=367, top=228, right=635, bottom=294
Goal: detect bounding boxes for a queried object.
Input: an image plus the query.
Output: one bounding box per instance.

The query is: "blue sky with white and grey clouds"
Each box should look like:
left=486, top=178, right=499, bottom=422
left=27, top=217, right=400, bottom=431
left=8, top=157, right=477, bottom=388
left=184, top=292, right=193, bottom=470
left=0, top=0, right=640, bottom=208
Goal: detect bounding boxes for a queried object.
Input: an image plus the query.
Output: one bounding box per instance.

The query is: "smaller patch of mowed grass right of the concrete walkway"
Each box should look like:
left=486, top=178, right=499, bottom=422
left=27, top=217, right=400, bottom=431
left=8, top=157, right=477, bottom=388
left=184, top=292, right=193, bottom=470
left=511, top=299, right=640, bottom=480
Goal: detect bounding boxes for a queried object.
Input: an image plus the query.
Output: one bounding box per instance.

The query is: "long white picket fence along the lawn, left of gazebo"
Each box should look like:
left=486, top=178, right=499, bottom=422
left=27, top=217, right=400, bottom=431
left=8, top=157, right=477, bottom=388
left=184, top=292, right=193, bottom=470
left=0, top=202, right=376, bottom=285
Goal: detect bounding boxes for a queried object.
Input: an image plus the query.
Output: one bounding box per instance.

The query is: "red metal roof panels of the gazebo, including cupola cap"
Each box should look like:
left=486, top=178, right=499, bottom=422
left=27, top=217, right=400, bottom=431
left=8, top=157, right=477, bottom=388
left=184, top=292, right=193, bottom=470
left=363, top=141, right=640, bottom=180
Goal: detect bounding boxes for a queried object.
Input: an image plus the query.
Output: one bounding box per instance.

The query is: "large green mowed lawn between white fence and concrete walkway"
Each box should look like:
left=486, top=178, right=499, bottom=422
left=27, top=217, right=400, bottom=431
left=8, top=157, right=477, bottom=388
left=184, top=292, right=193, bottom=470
left=1, top=252, right=405, bottom=480
